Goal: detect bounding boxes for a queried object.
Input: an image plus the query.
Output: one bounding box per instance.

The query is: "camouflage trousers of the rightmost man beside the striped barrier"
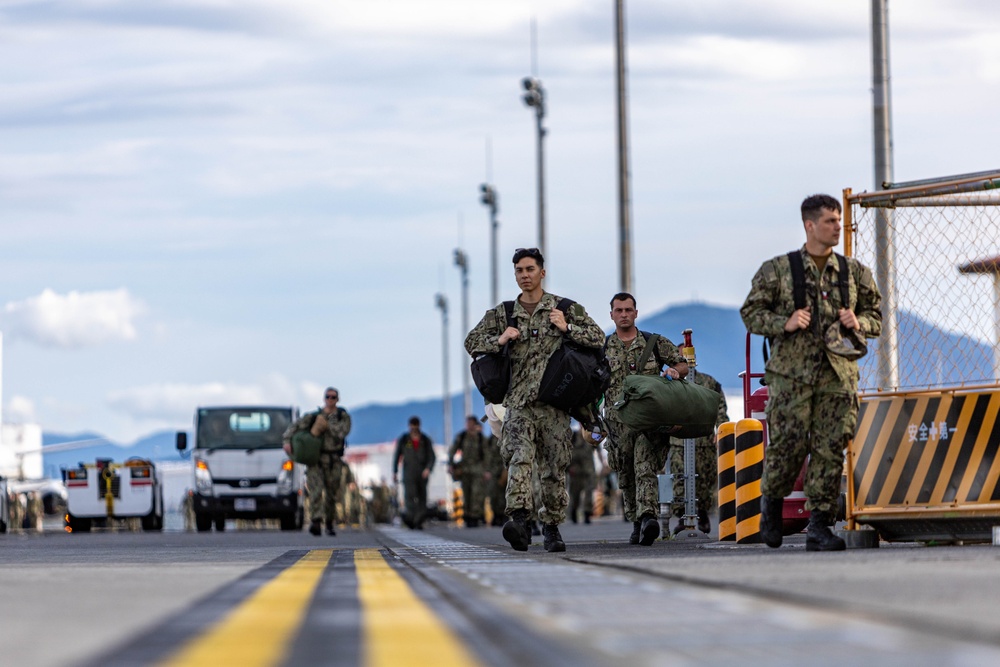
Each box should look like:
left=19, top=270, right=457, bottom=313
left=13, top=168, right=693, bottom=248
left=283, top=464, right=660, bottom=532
left=760, top=367, right=858, bottom=512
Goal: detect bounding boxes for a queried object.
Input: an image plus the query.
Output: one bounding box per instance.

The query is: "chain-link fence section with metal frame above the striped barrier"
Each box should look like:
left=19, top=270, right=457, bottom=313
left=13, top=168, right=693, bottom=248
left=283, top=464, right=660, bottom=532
left=844, top=171, right=1000, bottom=393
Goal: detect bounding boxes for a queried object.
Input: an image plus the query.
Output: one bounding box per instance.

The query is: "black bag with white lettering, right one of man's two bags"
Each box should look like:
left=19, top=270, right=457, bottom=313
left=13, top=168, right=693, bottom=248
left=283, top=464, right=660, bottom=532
left=538, top=299, right=611, bottom=412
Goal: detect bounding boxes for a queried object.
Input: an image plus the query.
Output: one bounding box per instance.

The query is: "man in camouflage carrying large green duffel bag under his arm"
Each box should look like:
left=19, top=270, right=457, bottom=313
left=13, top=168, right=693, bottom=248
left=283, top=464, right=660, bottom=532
left=604, top=292, right=684, bottom=546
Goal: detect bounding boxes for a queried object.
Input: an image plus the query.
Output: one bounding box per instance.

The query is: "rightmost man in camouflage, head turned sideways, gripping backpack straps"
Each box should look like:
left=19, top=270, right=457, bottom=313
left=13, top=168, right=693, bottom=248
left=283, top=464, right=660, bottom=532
left=740, top=195, right=882, bottom=551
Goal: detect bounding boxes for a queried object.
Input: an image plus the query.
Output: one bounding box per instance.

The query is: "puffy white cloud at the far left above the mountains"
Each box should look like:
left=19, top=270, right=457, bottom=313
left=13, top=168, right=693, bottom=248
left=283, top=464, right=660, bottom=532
left=3, top=288, right=145, bottom=348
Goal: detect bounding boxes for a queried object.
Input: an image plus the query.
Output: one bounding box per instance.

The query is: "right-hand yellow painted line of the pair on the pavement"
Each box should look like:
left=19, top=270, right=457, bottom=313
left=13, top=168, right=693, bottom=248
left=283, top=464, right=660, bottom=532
left=356, top=549, right=479, bottom=667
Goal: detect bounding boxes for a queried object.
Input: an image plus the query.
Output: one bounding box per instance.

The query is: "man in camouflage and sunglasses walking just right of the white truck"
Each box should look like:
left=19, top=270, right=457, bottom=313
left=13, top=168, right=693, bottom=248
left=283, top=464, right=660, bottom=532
left=282, top=387, right=351, bottom=535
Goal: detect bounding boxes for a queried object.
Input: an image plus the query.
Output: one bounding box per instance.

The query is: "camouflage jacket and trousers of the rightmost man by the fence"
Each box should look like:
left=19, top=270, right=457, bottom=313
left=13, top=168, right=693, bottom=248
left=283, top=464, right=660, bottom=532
left=740, top=245, right=882, bottom=513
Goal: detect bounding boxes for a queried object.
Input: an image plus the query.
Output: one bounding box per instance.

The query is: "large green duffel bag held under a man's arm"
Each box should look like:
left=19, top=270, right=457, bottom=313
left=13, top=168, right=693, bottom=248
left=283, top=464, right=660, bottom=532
left=615, top=375, right=723, bottom=439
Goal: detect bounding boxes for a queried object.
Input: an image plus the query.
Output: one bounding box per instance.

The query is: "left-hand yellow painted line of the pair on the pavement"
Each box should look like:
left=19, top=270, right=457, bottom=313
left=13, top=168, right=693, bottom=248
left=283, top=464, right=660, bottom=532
left=162, top=549, right=333, bottom=667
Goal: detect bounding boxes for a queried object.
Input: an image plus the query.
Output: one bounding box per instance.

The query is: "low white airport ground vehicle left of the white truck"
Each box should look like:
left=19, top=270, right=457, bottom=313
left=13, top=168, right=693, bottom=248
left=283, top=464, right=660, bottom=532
left=62, top=457, right=163, bottom=533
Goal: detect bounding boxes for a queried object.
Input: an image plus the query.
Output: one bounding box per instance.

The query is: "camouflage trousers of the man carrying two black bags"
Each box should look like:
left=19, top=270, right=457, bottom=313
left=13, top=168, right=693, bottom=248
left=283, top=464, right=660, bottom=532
left=500, top=402, right=573, bottom=524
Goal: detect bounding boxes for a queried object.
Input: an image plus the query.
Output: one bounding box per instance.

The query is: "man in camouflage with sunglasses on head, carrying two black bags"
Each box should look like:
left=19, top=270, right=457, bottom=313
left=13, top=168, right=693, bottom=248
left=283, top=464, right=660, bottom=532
left=465, top=248, right=604, bottom=551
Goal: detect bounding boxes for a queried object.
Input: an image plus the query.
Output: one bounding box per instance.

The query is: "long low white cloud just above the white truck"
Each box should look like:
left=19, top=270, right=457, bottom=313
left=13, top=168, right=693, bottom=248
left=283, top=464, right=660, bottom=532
left=107, top=374, right=325, bottom=424
